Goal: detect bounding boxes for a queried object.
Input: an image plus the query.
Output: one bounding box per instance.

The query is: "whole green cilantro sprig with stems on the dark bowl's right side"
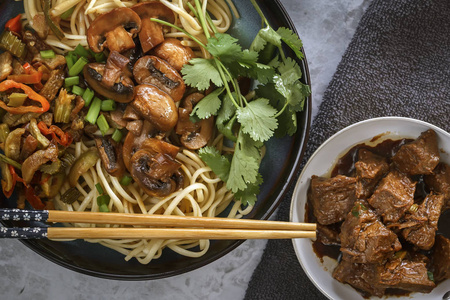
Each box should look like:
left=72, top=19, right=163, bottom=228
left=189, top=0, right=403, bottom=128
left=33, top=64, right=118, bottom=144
left=152, top=0, right=311, bottom=205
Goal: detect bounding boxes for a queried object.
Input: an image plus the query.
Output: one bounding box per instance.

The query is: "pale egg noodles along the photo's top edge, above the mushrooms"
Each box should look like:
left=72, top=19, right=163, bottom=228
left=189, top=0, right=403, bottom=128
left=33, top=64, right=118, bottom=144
left=24, top=0, right=239, bottom=57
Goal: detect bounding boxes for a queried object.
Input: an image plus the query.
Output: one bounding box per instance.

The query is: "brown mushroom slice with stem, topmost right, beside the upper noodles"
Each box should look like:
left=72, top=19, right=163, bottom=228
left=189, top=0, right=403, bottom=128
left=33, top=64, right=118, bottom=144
left=131, top=2, right=175, bottom=53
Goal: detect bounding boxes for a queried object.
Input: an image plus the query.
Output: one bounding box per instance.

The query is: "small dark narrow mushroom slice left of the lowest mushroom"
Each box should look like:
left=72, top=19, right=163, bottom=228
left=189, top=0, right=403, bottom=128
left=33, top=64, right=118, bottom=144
left=95, top=137, right=125, bottom=178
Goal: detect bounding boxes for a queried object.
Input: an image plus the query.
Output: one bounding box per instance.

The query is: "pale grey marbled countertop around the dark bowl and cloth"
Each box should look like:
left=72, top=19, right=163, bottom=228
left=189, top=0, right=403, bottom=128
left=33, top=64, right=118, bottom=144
left=0, top=0, right=370, bottom=300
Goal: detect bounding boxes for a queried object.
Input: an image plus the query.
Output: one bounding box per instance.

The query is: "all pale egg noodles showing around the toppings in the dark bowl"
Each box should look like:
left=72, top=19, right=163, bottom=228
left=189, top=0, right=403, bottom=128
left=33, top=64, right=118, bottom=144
left=19, top=0, right=253, bottom=264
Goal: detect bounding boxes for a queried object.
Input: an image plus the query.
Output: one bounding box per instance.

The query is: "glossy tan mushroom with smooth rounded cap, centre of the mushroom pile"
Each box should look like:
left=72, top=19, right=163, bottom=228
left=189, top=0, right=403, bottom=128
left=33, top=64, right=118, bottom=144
left=130, top=84, right=178, bottom=131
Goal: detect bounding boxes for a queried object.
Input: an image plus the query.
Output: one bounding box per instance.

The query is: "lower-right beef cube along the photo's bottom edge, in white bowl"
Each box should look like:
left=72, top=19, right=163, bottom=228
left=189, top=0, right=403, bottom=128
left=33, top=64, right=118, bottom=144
left=375, top=259, right=436, bottom=293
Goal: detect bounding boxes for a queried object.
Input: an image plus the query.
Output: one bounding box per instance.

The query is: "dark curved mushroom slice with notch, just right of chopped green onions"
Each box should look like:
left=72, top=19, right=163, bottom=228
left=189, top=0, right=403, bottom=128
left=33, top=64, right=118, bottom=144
left=83, top=63, right=134, bottom=103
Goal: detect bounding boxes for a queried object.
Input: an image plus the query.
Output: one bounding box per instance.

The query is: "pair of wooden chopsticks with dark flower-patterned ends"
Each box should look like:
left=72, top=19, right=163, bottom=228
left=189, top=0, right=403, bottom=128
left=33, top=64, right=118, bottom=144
left=0, top=209, right=316, bottom=240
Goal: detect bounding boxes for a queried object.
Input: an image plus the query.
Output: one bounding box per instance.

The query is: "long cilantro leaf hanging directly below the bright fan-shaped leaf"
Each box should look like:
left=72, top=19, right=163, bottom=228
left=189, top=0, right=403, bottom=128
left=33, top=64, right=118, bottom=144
left=227, top=132, right=259, bottom=193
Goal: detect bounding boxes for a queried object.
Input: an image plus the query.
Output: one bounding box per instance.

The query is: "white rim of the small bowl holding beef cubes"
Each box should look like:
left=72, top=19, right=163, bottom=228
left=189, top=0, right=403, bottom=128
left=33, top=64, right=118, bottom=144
left=289, top=116, right=450, bottom=299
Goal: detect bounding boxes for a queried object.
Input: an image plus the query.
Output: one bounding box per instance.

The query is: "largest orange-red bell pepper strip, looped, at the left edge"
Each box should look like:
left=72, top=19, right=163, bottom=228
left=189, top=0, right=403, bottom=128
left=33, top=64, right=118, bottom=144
left=0, top=80, right=50, bottom=114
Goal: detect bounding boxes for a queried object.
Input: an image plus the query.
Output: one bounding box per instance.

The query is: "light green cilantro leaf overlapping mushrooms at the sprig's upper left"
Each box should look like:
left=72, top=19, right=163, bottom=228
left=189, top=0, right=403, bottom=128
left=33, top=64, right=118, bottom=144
left=181, top=58, right=224, bottom=90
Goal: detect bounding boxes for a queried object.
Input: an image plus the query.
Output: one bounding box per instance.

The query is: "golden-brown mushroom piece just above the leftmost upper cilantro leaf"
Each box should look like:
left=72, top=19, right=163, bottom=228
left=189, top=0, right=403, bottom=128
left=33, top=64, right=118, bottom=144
left=153, top=38, right=195, bottom=72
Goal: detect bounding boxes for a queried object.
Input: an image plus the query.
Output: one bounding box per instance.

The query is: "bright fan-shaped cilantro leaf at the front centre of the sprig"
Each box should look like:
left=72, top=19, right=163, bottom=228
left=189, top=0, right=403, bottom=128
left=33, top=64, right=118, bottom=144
left=237, top=98, right=278, bottom=142
